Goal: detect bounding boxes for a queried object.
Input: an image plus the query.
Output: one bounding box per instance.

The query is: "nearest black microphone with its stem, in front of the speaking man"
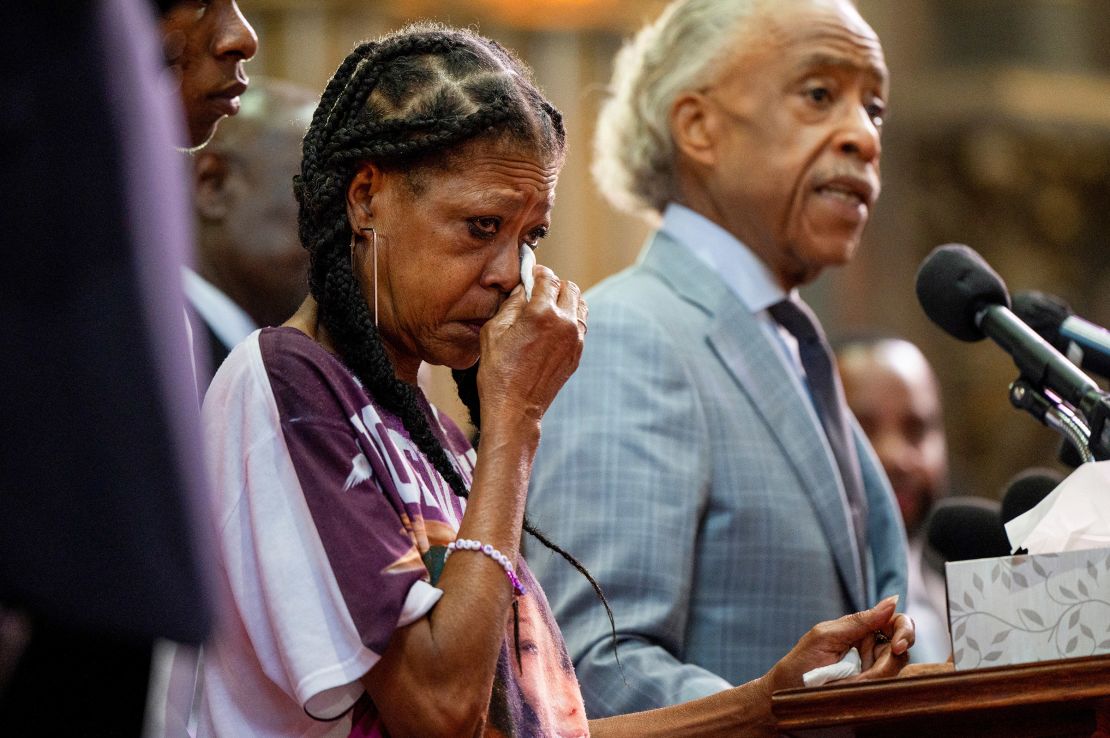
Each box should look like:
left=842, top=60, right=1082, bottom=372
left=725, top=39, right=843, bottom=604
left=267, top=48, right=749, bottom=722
left=916, top=244, right=1110, bottom=458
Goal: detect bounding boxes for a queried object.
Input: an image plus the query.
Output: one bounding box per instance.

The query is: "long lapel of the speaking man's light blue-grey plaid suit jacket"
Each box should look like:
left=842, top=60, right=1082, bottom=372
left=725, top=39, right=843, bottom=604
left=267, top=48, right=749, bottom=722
left=642, top=233, right=868, bottom=609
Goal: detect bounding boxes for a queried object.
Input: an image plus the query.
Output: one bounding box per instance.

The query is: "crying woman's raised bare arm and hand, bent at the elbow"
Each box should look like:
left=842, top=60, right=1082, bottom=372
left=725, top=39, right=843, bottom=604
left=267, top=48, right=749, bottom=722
left=362, top=266, right=586, bottom=736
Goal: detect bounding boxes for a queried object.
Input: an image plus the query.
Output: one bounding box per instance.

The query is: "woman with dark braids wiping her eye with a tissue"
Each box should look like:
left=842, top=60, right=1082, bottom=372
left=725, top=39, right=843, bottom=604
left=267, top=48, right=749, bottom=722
left=198, top=24, right=912, bottom=737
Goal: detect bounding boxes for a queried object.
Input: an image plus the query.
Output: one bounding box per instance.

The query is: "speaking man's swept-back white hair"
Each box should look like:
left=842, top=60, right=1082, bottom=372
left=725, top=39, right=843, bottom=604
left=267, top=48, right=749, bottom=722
left=593, top=0, right=766, bottom=215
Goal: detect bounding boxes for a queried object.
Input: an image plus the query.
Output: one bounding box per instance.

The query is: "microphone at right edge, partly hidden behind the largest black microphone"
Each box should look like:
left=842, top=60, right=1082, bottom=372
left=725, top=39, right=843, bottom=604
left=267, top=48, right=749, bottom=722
left=1013, top=290, right=1110, bottom=377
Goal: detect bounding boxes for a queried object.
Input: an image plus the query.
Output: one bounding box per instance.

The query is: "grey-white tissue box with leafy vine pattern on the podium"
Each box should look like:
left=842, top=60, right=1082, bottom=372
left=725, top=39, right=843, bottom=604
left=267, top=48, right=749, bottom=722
left=945, top=548, right=1110, bottom=669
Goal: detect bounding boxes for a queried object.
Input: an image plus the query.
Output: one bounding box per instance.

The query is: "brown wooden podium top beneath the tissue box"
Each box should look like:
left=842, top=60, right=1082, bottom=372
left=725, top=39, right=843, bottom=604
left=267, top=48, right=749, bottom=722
left=771, top=656, right=1110, bottom=738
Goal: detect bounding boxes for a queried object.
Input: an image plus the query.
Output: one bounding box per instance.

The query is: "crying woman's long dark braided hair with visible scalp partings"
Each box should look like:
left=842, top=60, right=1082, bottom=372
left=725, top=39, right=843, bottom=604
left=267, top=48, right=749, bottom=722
left=293, top=22, right=619, bottom=663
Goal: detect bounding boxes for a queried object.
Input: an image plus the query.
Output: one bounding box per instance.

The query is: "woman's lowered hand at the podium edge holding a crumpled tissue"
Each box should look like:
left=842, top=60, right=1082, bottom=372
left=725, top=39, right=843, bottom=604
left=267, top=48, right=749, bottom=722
left=763, top=596, right=915, bottom=694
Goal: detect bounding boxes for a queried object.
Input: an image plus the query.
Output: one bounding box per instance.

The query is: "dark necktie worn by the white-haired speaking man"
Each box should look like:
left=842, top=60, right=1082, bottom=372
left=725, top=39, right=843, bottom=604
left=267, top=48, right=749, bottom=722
left=768, top=300, right=867, bottom=576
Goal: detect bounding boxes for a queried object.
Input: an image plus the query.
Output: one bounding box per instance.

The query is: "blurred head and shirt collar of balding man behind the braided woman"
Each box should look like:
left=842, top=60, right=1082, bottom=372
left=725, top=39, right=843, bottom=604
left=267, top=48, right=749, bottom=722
left=184, top=78, right=316, bottom=371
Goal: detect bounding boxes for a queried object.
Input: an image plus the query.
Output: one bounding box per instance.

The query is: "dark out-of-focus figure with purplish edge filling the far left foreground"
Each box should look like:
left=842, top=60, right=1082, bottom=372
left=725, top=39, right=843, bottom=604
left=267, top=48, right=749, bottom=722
left=0, top=0, right=238, bottom=736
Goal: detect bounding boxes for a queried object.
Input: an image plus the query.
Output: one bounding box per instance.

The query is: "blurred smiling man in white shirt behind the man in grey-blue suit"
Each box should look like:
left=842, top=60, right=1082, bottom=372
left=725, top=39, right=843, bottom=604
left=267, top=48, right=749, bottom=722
left=836, top=337, right=951, bottom=663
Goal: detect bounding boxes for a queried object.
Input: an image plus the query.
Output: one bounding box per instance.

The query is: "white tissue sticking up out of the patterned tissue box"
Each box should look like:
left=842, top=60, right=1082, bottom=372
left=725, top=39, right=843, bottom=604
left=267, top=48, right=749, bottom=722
left=1006, top=462, right=1110, bottom=554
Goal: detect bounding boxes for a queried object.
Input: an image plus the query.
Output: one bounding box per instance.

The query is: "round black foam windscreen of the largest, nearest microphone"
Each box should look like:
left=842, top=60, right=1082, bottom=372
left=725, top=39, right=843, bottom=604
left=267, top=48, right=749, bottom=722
left=917, top=243, right=1010, bottom=341
